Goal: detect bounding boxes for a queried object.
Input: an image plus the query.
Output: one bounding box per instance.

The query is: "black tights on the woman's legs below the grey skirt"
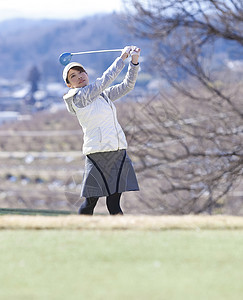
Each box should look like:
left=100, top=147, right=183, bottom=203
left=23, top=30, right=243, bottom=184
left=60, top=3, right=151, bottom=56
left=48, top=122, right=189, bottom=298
left=78, top=193, right=123, bottom=215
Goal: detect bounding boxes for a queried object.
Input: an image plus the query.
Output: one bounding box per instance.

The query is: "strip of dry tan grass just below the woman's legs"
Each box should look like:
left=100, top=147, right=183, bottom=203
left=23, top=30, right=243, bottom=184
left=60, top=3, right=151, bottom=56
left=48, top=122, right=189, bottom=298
left=0, top=215, right=243, bottom=230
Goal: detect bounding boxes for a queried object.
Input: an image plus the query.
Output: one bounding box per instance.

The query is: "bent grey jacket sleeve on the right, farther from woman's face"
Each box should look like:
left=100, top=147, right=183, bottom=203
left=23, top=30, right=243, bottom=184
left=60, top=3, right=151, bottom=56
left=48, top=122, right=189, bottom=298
left=104, top=62, right=139, bottom=101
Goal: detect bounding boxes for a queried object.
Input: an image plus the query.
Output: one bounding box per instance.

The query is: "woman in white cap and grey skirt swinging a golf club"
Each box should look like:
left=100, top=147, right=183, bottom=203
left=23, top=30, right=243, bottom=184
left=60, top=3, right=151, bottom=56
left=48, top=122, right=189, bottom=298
left=63, top=46, right=140, bottom=215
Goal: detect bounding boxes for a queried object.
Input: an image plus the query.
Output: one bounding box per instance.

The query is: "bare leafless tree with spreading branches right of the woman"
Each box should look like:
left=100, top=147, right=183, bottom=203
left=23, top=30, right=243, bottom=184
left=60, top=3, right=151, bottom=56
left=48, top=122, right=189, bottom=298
left=121, top=0, right=243, bottom=213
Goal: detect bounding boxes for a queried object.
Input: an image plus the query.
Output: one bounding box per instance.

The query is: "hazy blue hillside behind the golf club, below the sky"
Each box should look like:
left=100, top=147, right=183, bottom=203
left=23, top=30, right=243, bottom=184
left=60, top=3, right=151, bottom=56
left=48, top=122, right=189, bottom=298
left=0, top=13, right=146, bottom=81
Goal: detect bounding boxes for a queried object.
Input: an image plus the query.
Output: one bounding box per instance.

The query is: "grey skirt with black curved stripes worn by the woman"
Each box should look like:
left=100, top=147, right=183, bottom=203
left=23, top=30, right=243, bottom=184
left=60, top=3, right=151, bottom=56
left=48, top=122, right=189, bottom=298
left=81, top=149, right=139, bottom=198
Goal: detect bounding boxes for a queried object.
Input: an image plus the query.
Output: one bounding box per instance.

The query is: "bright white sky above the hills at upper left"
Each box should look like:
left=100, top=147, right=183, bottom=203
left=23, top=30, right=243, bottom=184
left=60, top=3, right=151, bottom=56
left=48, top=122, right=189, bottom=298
left=0, top=0, right=122, bottom=21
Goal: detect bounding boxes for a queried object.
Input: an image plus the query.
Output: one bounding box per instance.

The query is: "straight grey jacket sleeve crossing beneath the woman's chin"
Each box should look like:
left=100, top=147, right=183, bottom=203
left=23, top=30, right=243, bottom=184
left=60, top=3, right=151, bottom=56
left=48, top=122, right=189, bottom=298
left=73, top=57, right=125, bottom=108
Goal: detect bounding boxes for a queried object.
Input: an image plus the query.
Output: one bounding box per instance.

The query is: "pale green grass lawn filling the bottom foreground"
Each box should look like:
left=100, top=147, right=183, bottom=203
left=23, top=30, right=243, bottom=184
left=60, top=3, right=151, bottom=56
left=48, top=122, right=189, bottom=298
left=0, top=230, right=243, bottom=300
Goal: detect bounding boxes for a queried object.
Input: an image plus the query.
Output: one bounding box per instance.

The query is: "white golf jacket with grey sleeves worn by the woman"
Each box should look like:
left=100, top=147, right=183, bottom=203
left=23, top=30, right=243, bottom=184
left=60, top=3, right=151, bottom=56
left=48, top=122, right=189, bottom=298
left=63, top=58, right=139, bottom=155
